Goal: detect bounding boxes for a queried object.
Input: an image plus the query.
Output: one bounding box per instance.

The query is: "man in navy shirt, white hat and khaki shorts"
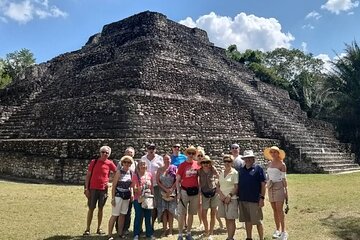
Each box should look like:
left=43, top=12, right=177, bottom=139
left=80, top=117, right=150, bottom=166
left=238, top=150, right=266, bottom=240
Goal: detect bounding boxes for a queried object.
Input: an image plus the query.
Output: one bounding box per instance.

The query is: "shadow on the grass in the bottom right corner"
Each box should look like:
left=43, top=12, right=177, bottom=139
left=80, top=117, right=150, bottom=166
left=321, top=214, right=360, bottom=240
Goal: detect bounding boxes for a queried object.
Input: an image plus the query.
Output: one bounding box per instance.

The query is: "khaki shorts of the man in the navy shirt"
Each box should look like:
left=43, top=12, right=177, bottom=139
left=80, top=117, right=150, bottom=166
left=239, top=201, right=263, bottom=225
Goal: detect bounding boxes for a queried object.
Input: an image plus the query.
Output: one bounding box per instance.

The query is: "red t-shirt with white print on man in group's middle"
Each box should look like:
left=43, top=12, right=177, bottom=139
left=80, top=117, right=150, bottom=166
left=176, top=161, right=200, bottom=188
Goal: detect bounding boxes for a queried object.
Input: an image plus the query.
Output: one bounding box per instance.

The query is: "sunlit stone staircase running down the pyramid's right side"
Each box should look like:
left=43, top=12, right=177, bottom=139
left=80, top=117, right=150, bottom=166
left=224, top=68, right=360, bottom=173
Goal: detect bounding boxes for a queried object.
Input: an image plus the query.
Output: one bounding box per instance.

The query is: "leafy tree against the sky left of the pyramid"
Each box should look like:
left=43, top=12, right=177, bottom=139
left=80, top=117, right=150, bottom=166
left=4, top=48, right=35, bottom=80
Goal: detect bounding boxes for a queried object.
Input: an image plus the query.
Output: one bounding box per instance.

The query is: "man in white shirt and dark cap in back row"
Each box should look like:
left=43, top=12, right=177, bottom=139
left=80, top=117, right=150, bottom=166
left=140, top=143, right=164, bottom=228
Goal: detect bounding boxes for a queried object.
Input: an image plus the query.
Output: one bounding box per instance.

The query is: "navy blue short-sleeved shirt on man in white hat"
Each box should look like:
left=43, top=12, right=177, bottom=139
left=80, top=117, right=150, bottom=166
left=238, top=164, right=266, bottom=202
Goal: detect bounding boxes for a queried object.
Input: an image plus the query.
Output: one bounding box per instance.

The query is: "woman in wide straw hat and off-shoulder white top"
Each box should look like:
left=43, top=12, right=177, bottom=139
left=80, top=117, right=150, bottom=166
left=264, top=146, right=288, bottom=240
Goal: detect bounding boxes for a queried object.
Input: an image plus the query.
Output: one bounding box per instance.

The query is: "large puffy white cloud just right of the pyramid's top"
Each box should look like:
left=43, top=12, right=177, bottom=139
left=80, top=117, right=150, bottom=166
left=180, top=12, right=295, bottom=51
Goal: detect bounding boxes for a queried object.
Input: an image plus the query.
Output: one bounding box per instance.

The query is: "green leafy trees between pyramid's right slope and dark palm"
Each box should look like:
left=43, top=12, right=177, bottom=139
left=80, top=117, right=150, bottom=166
left=227, top=45, right=328, bottom=116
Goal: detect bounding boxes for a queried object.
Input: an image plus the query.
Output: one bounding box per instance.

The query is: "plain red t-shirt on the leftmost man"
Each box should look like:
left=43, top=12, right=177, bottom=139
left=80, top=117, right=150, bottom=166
left=88, top=159, right=116, bottom=190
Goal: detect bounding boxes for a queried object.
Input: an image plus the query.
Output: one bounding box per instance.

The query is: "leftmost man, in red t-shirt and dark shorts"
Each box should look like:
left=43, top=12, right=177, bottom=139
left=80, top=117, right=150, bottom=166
left=83, top=146, right=116, bottom=235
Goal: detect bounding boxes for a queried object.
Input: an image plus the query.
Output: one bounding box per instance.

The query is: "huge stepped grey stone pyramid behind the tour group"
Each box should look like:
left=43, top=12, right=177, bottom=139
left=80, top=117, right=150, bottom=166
left=0, top=12, right=360, bottom=182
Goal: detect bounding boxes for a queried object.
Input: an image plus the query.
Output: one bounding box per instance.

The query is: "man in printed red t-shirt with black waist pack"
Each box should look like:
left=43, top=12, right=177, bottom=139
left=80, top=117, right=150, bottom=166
left=176, top=146, right=199, bottom=240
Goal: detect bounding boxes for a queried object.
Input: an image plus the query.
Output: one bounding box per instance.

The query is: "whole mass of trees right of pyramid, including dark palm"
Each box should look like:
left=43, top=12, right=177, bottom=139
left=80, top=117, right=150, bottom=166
left=227, top=41, right=360, bottom=156
